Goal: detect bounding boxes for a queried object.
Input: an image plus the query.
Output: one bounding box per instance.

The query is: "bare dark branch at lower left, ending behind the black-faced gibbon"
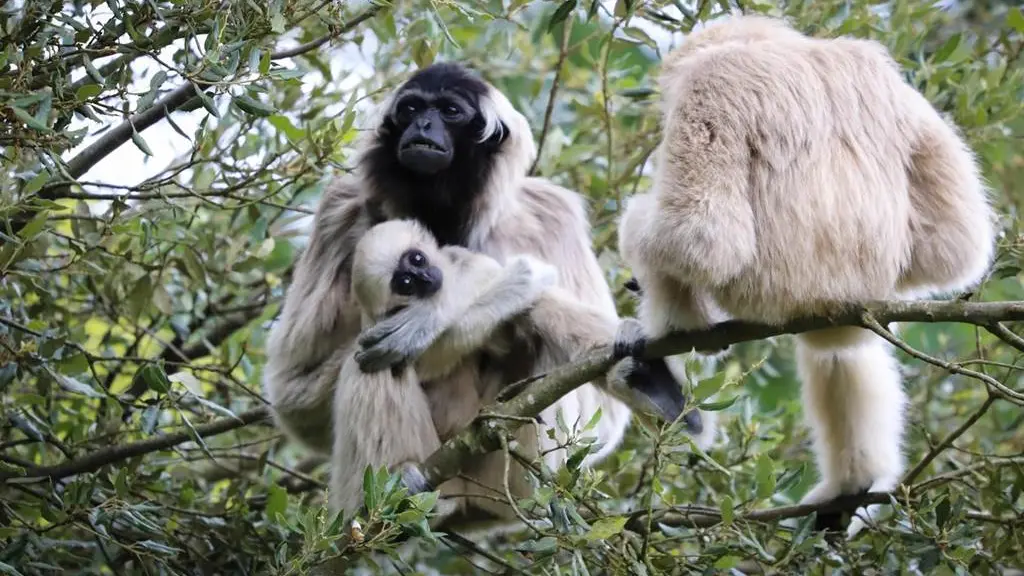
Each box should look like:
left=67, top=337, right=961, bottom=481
left=0, top=408, right=270, bottom=483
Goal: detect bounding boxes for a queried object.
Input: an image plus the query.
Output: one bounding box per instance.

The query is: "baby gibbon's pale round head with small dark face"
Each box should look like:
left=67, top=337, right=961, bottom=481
left=352, top=220, right=444, bottom=319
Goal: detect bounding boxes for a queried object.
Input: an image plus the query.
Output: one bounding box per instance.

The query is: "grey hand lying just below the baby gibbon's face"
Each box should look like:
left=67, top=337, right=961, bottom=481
left=355, top=301, right=445, bottom=372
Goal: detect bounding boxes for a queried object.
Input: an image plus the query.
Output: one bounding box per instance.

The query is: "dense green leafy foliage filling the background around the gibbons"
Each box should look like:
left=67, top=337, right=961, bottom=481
left=0, top=0, right=1024, bottom=575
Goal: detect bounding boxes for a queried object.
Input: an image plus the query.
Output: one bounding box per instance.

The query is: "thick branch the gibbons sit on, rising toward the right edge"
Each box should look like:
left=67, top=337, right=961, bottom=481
left=415, top=300, right=1024, bottom=486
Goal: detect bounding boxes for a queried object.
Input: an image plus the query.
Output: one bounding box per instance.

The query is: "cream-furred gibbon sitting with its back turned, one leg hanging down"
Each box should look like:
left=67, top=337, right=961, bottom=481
left=618, top=16, right=994, bottom=537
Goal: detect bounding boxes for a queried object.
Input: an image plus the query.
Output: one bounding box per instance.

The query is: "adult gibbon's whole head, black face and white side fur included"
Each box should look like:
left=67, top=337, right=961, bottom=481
left=359, top=63, right=537, bottom=245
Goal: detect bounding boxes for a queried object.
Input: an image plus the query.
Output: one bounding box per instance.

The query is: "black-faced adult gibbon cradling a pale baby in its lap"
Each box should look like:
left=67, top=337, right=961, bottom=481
left=264, top=64, right=699, bottom=520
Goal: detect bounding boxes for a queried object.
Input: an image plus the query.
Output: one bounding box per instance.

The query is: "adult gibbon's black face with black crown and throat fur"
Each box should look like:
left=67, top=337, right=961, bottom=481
left=360, top=63, right=509, bottom=246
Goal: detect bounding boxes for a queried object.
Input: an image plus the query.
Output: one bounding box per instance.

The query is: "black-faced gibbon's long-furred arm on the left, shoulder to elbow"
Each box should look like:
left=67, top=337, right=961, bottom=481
left=263, top=180, right=369, bottom=454
